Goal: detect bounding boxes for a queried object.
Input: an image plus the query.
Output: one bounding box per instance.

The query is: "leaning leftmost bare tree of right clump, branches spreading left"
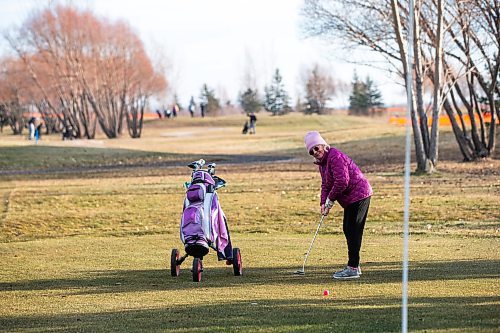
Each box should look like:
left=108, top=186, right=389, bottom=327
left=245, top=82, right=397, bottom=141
left=303, top=0, right=432, bottom=172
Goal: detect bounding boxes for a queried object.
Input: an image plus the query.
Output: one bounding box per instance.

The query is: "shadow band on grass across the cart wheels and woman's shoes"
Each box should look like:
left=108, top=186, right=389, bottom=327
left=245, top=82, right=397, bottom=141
left=0, top=259, right=500, bottom=295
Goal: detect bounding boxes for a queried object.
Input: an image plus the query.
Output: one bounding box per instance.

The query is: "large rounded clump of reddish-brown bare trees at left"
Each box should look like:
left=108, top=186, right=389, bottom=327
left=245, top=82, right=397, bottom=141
left=7, top=5, right=166, bottom=139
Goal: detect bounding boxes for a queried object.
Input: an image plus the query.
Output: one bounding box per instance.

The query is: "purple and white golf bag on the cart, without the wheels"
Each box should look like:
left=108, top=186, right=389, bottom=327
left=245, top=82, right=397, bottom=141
left=180, top=169, right=233, bottom=260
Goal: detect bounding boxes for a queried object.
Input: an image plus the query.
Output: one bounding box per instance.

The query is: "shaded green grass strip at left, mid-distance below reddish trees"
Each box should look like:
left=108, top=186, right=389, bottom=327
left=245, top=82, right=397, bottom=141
left=0, top=146, right=292, bottom=176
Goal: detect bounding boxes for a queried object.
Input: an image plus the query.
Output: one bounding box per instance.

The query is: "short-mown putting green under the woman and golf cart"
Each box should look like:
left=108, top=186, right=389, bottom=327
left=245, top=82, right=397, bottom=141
left=0, top=233, right=500, bottom=332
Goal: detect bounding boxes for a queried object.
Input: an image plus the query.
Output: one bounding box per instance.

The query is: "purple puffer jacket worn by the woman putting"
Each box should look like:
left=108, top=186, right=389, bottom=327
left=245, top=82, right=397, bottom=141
left=314, top=148, right=373, bottom=208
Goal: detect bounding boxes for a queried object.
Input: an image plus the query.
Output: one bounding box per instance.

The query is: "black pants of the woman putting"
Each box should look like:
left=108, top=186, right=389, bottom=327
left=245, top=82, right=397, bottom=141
left=342, top=197, right=370, bottom=267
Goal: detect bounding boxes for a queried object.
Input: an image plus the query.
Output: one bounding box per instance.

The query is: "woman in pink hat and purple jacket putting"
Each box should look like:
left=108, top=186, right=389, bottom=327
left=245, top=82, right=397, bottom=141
left=304, top=131, right=373, bottom=279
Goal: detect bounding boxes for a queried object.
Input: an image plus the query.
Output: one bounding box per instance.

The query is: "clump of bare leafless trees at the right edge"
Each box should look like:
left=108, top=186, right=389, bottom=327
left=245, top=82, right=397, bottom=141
left=303, top=0, right=500, bottom=172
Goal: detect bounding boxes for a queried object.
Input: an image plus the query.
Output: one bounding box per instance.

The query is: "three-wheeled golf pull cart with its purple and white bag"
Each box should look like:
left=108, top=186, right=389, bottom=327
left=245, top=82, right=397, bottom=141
left=170, top=159, right=243, bottom=282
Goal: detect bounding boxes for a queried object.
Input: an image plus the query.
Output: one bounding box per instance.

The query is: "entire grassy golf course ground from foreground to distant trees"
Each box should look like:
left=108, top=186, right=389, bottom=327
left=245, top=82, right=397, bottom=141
left=0, top=115, right=500, bottom=332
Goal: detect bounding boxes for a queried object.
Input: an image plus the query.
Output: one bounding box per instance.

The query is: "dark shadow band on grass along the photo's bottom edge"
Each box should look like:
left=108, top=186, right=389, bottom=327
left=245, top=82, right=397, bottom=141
left=0, top=296, right=500, bottom=332
